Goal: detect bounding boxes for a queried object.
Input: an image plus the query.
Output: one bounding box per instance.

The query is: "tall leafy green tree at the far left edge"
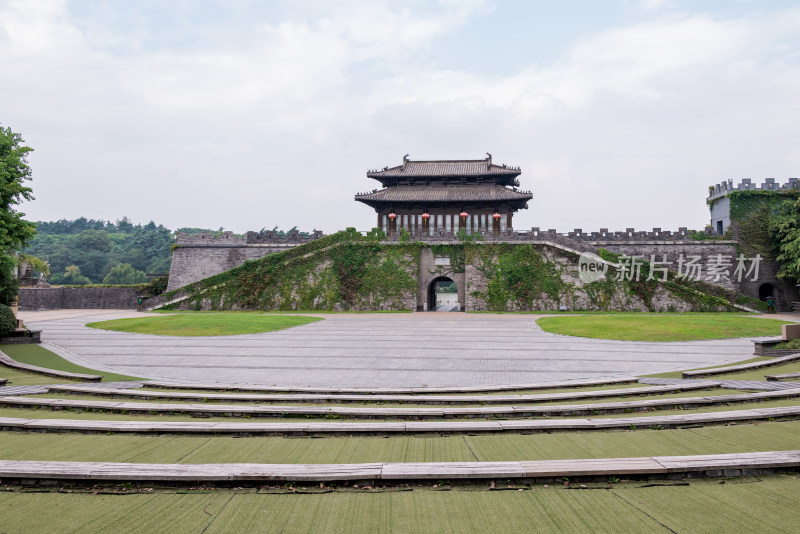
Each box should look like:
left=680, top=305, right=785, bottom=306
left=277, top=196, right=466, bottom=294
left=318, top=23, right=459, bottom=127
left=0, top=126, right=36, bottom=304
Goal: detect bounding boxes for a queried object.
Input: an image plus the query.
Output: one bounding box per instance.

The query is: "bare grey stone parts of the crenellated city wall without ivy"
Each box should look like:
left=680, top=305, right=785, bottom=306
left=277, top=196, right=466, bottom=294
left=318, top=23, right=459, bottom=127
left=168, top=227, right=797, bottom=310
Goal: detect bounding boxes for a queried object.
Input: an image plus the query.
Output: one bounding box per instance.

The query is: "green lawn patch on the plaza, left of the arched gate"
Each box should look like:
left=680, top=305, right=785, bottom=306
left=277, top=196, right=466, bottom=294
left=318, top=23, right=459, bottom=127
left=86, top=312, right=322, bottom=336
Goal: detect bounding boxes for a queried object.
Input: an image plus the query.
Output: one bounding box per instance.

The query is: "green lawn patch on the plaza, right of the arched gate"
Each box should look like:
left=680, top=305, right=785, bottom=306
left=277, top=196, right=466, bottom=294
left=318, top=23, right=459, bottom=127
left=537, top=313, right=791, bottom=341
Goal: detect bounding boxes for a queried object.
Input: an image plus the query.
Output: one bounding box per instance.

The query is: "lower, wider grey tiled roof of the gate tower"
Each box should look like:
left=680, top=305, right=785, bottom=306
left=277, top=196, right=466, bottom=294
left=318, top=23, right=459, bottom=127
left=356, top=184, right=533, bottom=204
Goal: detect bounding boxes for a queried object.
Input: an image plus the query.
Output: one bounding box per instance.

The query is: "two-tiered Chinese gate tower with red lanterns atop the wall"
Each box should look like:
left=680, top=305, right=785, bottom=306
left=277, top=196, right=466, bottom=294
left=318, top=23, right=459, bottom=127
left=355, top=154, right=533, bottom=238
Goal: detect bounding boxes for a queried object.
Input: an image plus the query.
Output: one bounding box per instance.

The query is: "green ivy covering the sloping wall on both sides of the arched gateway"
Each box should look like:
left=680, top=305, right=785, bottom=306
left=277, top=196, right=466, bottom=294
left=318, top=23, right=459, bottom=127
left=159, top=233, right=763, bottom=311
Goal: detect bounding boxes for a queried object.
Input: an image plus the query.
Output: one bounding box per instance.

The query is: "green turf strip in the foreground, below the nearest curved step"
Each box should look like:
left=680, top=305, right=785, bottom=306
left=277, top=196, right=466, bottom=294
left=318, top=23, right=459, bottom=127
left=0, top=476, right=800, bottom=534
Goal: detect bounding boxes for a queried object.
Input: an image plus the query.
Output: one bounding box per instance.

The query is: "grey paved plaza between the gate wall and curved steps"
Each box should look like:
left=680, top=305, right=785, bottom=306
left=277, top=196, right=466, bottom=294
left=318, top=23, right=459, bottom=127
left=22, top=310, right=768, bottom=388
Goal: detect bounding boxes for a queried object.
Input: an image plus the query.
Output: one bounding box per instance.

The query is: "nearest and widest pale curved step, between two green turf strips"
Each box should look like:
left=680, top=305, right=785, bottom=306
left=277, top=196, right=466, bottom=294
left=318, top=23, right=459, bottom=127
left=0, top=450, right=800, bottom=485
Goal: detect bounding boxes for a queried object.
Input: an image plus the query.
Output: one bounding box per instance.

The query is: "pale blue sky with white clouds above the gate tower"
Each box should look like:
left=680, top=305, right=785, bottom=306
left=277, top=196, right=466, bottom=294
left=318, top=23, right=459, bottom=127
left=0, top=0, right=800, bottom=233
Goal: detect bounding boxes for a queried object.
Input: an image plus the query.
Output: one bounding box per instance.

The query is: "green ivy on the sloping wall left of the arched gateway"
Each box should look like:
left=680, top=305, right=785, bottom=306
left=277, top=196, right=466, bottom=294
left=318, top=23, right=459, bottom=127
left=165, top=229, right=420, bottom=310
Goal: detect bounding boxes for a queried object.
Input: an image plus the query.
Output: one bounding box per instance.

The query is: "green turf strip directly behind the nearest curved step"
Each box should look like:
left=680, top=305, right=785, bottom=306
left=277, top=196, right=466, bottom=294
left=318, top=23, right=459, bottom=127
left=0, top=421, right=800, bottom=464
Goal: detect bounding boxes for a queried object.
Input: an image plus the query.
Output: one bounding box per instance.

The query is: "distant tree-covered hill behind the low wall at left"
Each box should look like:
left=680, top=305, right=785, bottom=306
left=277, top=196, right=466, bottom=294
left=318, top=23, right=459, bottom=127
left=23, top=217, right=174, bottom=284
